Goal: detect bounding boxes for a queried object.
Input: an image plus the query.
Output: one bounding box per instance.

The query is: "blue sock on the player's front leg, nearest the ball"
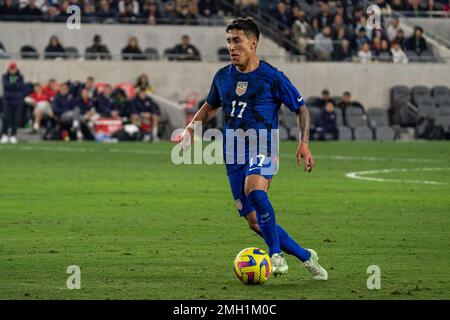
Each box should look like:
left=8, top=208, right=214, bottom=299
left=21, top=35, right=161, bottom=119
left=247, top=190, right=281, bottom=256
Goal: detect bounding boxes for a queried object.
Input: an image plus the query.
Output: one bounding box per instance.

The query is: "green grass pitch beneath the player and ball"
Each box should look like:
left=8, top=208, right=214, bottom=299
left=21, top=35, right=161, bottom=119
left=0, top=142, right=450, bottom=299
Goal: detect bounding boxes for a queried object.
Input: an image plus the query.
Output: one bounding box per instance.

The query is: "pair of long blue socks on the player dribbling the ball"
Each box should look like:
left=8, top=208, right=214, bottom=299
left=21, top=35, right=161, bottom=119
left=247, top=190, right=311, bottom=262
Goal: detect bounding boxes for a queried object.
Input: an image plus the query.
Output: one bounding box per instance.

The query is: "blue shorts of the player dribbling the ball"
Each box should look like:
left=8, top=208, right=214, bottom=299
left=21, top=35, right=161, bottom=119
left=227, top=158, right=276, bottom=217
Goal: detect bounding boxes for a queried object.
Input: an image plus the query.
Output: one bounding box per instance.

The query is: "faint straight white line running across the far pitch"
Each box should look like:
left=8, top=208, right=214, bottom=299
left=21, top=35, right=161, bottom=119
left=0, top=145, right=446, bottom=163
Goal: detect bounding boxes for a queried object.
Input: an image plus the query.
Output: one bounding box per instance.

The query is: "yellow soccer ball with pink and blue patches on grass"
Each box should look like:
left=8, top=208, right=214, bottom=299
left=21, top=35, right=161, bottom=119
left=234, top=247, right=272, bottom=284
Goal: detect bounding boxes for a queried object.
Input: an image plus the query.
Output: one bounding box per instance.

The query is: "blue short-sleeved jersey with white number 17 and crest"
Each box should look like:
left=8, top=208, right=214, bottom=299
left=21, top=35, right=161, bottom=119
left=207, top=60, right=304, bottom=173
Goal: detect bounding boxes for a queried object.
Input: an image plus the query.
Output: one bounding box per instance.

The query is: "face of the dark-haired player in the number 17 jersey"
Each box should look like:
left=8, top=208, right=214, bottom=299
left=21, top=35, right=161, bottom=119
left=227, top=30, right=257, bottom=66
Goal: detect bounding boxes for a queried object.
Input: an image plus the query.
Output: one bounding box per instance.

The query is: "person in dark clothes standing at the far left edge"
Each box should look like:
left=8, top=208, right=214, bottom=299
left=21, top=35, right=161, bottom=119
left=1, top=62, right=24, bottom=144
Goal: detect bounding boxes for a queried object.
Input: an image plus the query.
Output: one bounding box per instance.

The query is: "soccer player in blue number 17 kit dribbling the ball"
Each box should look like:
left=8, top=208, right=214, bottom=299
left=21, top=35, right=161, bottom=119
left=180, top=18, right=328, bottom=280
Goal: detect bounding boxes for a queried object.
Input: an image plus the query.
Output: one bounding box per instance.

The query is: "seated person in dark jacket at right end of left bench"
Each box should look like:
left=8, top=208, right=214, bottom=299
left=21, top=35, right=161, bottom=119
left=131, top=90, right=160, bottom=141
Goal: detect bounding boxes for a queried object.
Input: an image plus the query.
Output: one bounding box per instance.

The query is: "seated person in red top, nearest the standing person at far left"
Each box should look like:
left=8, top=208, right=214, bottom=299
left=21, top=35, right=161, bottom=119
left=25, top=82, right=53, bottom=133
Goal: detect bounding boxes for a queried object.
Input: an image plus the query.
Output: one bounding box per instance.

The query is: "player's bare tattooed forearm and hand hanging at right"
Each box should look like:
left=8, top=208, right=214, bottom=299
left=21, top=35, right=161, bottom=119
left=295, top=105, right=314, bottom=172
